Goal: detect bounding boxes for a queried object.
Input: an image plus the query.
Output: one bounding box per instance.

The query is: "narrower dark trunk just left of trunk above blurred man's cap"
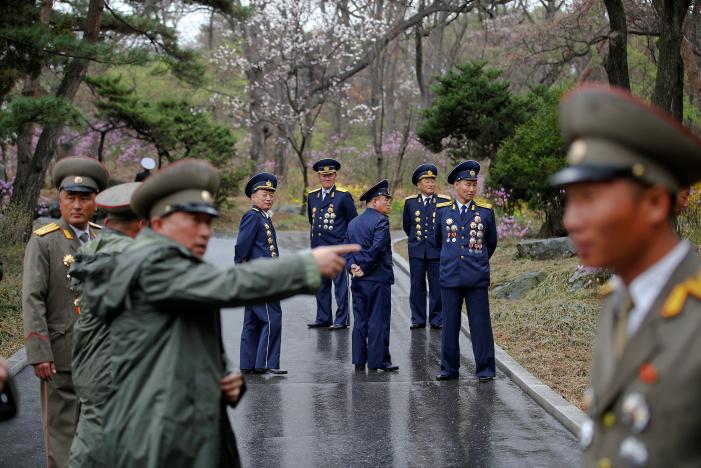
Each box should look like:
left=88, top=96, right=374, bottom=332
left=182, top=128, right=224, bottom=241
left=604, top=0, right=630, bottom=90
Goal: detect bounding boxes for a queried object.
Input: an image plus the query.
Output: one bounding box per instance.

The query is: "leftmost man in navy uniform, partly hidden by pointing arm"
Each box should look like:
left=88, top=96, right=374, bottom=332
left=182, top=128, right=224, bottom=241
left=234, top=172, right=287, bottom=374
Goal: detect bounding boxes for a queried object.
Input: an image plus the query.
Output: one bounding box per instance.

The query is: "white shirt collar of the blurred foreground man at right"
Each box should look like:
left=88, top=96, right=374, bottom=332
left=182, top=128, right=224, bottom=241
left=617, top=241, right=690, bottom=336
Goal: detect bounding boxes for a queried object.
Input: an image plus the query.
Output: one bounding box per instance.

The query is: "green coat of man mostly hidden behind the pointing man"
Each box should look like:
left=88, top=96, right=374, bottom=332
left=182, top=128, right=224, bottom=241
left=69, top=229, right=134, bottom=468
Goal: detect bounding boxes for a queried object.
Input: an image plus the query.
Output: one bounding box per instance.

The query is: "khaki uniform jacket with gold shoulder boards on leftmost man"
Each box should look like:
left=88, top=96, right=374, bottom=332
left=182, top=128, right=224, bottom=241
left=22, top=219, right=97, bottom=372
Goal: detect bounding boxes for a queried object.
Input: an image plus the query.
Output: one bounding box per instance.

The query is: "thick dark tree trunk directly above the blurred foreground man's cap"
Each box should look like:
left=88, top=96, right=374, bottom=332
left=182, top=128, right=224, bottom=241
left=652, top=0, right=691, bottom=120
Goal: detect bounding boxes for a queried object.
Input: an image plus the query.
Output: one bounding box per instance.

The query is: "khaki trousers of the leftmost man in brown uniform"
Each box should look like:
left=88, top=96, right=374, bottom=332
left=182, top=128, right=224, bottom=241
left=40, top=371, right=80, bottom=468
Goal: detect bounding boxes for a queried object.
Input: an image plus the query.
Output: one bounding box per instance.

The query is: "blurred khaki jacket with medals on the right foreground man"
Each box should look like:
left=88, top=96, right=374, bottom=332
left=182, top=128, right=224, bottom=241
left=583, top=247, right=701, bottom=467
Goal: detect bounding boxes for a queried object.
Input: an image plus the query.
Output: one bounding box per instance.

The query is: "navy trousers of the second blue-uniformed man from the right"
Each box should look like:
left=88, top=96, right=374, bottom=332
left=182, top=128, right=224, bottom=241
left=409, top=257, right=443, bottom=326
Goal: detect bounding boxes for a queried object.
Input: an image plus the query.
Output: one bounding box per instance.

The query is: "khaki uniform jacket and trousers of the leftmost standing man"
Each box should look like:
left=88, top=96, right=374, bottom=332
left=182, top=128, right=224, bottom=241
left=22, top=219, right=97, bottom=467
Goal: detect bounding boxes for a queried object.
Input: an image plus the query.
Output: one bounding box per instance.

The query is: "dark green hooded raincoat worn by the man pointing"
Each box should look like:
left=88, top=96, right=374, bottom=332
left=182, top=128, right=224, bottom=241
left=81, top=229, right=320, bottom=467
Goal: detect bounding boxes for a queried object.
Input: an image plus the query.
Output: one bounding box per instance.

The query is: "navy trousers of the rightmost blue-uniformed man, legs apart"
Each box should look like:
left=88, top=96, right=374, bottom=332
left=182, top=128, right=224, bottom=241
left=441, top=288, right=496, bottom=377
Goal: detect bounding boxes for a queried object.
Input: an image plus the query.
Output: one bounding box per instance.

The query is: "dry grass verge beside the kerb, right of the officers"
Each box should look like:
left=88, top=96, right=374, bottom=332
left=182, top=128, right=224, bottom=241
left=395, top=242, right=599, bottom=407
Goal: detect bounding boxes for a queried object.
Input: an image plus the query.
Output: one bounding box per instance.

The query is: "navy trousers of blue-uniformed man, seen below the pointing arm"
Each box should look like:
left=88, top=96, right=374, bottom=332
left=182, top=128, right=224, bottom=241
left=241, top=302, right=282, bottom=369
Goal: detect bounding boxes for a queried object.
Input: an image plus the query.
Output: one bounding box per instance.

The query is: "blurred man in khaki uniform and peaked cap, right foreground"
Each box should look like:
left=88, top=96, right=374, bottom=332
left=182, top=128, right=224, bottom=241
left=552, top=86, right=701, bottom=467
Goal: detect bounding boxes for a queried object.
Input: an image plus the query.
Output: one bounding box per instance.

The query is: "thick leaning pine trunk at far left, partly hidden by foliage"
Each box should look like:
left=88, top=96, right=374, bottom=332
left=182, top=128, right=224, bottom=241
left=11, top=0, right=104, bottom=236
